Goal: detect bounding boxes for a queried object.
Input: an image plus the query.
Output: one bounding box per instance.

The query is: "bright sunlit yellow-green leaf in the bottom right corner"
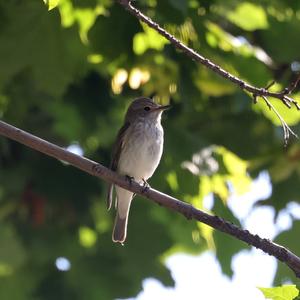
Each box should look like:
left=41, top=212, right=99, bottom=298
left=259, top=285, right=299, bottom=300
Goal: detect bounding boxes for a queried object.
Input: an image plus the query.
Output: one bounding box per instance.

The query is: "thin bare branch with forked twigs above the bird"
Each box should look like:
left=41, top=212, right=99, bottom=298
left=118, top=0, right=300, bottom=145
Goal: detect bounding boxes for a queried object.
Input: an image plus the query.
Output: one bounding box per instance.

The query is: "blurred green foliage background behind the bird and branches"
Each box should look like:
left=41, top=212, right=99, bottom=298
left=0, top=0, right=300, bottom=300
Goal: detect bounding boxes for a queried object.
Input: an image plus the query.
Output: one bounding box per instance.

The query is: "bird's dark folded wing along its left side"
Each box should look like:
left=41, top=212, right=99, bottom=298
left=106, top=122, right=130, bottom=210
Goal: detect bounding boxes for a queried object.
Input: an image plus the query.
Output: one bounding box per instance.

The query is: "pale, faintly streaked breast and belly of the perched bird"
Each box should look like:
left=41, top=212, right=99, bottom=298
left=118, top=120, right=163, bottom=181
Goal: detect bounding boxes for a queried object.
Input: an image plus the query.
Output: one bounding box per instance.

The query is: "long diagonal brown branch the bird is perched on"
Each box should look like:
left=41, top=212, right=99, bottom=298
left=0, top=121, right=300, bottom=278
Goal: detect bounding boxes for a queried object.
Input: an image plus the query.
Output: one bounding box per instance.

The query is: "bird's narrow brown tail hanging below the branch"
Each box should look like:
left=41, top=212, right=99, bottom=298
left=112, top=187, right=133, bottom=244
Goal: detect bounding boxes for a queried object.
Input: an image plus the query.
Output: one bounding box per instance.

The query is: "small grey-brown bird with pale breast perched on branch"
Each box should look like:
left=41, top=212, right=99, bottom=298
left=107, top=98, right=169, bottom=244
